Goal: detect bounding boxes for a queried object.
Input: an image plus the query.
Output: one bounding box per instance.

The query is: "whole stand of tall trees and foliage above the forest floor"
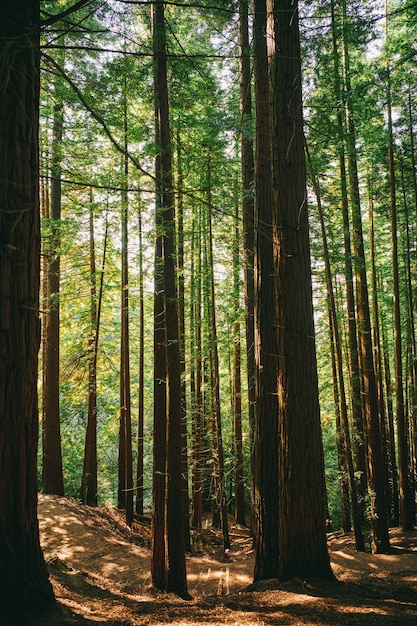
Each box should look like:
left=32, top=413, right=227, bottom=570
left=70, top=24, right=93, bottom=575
left=0, top=0, right=417, bottom=623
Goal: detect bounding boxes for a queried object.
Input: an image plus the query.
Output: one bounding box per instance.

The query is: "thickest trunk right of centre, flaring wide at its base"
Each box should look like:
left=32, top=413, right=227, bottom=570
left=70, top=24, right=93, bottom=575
left=267, top=0, right=333, bottom=580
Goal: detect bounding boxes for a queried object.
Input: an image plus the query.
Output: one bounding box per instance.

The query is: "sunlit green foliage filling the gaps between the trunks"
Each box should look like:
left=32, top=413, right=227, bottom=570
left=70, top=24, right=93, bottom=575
left=35, top=0, right=417, bottom=529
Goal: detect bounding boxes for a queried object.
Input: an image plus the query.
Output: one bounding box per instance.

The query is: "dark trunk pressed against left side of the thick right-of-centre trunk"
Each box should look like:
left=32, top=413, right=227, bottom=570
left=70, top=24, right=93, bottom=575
left=253, top=0, right=279, bottom=581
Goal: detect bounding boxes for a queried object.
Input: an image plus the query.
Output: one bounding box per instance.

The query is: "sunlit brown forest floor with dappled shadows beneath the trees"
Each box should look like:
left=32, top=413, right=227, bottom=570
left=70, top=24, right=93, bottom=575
left=21, top=495, right=417, bottom=626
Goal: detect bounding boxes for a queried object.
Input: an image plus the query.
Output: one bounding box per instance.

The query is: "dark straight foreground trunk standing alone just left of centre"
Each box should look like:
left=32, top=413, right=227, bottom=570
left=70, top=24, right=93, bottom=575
left=152, top=0, right=190, bottom=598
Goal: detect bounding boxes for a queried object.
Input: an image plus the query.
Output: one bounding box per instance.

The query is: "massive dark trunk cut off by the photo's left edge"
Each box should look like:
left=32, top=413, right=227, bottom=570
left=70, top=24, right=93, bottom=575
left=0, top=0, right=54, bottom=612
